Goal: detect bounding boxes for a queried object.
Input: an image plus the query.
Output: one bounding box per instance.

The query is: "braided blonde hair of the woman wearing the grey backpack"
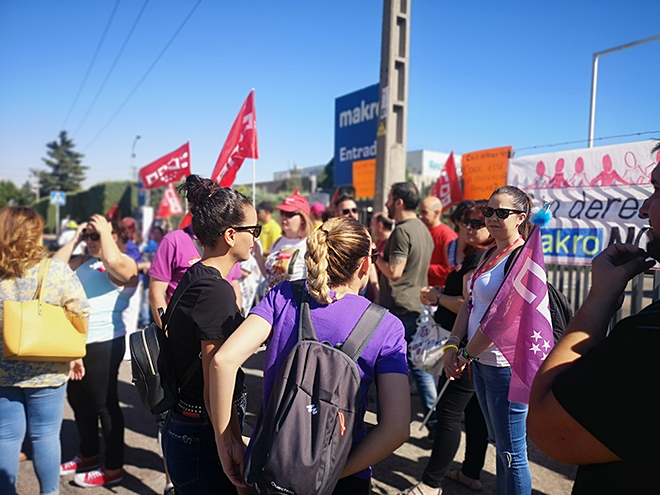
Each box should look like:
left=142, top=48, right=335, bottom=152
left=305, top=217, right=371, bottom=304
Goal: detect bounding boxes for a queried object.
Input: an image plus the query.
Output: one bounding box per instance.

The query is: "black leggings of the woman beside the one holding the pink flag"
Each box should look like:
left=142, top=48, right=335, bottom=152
left=422, top=368, right=488, bottom=488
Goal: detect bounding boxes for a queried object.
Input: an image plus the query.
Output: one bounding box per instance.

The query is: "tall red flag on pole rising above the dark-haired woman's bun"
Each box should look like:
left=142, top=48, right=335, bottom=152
left=211, top=89, right=259, bottom=187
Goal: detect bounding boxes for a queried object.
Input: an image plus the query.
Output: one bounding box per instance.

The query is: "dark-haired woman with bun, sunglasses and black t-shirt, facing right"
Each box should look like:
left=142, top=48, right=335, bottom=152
left=163, top=175, right=261, bottom=495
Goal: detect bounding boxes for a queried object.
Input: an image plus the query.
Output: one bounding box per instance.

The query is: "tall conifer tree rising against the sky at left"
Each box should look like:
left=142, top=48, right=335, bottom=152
left=30, top=131, right=89, bottom=197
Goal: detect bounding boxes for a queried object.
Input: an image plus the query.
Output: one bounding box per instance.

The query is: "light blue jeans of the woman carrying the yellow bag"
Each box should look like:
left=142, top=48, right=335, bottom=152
left=0, top=385, right=66, bottom=494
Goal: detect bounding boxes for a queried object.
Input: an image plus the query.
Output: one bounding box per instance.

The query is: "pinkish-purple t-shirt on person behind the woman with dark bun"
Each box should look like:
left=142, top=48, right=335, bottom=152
left=149, top=227, right=202, bottom=302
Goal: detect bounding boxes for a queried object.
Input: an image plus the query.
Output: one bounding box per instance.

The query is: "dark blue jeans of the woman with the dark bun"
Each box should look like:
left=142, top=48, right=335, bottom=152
left=163, top=407, right=237, bottom=495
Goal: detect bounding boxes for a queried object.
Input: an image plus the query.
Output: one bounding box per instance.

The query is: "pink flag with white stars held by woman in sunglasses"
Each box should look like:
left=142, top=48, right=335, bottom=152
left=480, top=226, right=554, bottom=404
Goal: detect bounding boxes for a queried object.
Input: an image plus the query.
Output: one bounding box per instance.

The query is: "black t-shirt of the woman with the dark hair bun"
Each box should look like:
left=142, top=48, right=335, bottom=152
left=165, top=262, right=243, bottom=406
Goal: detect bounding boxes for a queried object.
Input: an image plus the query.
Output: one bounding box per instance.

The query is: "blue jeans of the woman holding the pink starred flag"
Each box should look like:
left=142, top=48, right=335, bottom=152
left=472, top=361, right=532, bottom=495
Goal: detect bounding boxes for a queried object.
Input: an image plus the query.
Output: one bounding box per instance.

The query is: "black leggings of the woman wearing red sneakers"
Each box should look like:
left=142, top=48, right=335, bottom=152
left=67, top=336, right=126, bottom=469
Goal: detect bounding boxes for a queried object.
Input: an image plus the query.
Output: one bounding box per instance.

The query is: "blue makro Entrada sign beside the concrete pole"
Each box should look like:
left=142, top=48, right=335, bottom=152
left=334, top=84, right=379, bottom=186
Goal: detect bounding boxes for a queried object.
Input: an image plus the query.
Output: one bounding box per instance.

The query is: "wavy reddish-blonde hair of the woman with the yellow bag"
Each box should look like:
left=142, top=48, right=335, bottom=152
left=0, top=206, right=46, bottom=278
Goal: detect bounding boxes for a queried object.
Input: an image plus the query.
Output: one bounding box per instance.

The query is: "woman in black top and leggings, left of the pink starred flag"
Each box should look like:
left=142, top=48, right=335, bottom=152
left=401, top=201, right=494, bottom=495
